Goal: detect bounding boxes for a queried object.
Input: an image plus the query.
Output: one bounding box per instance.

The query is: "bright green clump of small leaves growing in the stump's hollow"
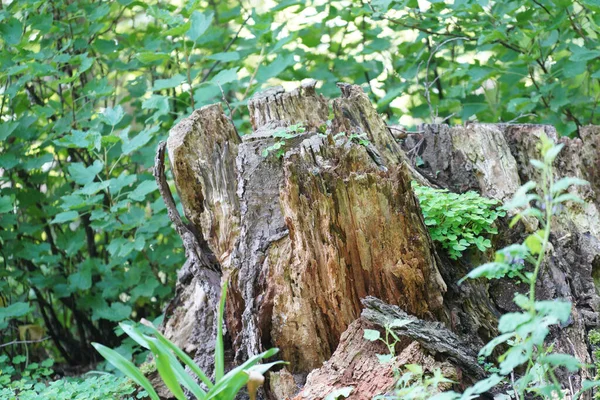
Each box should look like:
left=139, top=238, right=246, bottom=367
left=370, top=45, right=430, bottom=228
left=413, top=182, right=506, bottom=260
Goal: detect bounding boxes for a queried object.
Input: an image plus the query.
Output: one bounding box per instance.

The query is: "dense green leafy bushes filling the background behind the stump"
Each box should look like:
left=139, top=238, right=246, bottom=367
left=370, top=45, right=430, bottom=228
left=0, top=0, right=600, bottom=370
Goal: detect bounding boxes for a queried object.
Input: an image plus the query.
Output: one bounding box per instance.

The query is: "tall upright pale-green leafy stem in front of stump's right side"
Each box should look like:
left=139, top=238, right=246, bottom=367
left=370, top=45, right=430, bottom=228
left=463, top=135, right=600, bottom=399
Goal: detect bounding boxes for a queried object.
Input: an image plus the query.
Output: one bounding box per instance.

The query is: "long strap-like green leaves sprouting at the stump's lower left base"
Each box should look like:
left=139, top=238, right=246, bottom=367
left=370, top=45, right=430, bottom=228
left=93, top=284, right=282, bottom=400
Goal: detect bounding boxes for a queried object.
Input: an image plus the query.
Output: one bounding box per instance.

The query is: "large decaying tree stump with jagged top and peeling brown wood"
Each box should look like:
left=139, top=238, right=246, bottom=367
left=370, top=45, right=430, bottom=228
left=156, top=82, right=600, bottom=399
